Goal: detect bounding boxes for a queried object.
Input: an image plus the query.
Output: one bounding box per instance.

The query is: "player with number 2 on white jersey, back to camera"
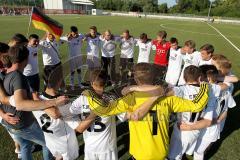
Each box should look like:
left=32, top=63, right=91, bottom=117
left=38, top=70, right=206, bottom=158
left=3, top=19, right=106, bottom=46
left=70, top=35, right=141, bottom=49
left=33, top=71, right=80, bottom=160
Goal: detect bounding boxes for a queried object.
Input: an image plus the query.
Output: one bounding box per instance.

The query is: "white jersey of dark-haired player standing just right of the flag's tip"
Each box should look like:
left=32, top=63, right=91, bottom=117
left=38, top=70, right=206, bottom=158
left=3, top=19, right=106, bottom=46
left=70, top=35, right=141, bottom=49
left=61, top=34, right=85, bottom=58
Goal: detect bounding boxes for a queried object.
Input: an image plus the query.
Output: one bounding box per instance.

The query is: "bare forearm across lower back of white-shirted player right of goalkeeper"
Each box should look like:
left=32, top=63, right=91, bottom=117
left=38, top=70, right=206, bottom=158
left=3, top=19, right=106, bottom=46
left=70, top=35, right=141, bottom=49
left=178, top=119, right=212, bottom=131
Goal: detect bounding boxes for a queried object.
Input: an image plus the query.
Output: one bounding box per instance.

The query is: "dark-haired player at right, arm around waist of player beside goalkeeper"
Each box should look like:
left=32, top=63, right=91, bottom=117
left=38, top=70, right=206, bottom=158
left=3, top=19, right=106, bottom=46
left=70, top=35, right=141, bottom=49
left=180, top=65, right=232, bottom=160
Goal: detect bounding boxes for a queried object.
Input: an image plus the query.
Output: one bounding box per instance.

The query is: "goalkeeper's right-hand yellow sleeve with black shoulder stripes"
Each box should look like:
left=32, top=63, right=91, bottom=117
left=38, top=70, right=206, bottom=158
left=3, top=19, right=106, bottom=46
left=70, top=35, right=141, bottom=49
left=169, top=83, right=209, bottom=112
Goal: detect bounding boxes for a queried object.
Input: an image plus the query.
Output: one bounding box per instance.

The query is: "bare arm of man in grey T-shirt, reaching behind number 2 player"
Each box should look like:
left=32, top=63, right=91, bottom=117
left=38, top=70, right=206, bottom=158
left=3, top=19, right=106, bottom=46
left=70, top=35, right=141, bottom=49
left=11, top=89, right=69, bottom=111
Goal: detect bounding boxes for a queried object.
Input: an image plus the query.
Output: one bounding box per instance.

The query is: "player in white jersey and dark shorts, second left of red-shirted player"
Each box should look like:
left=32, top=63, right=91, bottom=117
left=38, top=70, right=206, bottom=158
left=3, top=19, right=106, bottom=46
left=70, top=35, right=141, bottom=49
left=119, top=30, right=136, bottom=82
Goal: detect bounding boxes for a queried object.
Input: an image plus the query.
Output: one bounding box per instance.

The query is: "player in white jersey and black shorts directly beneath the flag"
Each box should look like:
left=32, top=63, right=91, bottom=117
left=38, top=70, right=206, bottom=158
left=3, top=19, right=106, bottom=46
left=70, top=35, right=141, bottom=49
left=39, top=33, right=65, bottom=89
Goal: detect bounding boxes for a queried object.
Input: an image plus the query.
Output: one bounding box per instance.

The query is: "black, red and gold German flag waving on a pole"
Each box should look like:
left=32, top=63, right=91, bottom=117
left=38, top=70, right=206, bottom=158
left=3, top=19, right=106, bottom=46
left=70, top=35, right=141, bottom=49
left=32, top=7, right=63, bottom=40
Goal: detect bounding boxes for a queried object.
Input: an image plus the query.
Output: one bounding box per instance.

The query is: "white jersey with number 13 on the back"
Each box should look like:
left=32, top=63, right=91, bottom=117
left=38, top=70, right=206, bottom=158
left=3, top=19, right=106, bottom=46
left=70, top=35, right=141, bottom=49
left=70, top=95, right=124, bottom=153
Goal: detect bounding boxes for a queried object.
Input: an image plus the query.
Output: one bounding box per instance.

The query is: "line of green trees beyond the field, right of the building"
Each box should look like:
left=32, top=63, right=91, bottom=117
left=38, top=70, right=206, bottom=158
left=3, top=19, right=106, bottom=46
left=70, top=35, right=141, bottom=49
left=93, top=0, right=240, bottom=17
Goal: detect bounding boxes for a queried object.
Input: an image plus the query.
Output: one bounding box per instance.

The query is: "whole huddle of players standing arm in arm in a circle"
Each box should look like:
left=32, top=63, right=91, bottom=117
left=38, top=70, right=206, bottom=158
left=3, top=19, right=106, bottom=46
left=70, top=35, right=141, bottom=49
left=0, top=26, right=238, bottom=160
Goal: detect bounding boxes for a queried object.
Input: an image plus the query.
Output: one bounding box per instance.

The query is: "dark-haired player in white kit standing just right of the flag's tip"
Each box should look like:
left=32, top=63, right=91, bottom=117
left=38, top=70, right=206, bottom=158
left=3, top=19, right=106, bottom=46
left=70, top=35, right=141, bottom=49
left=61, top=26, right=85, bottom=90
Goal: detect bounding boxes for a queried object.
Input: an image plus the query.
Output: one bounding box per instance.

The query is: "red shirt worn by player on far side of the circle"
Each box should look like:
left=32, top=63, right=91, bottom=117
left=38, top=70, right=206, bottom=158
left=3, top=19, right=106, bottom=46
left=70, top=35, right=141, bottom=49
left=152, top=40, right=171, bottom=66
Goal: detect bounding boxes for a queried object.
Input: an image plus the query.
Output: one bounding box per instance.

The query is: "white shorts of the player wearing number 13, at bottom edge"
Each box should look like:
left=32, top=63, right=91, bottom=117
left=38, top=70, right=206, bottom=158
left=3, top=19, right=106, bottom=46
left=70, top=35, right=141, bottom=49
left=84, top=150, right=118, bottom=160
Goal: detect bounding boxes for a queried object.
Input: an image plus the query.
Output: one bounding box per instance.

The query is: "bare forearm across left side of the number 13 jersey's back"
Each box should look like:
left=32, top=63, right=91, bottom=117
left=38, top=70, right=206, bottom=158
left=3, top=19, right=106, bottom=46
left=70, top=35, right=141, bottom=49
left=75, top=112, right=96, bottom=133
